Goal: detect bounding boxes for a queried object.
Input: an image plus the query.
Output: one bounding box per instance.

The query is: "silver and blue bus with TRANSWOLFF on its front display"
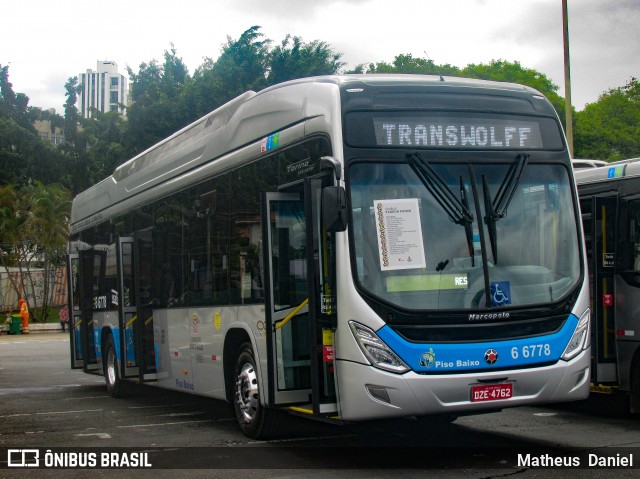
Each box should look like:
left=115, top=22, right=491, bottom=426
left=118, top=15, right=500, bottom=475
left=69, top=75, right=590, bottom=438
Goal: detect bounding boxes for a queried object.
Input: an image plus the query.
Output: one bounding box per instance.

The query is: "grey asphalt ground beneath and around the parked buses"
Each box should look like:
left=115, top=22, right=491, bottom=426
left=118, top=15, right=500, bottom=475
left=0, top=333, right=640, bottom=478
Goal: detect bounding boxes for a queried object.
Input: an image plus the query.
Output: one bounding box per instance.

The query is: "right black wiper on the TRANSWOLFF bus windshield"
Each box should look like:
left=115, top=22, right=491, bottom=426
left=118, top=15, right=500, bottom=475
left=482, top=154, right=529, bottom=264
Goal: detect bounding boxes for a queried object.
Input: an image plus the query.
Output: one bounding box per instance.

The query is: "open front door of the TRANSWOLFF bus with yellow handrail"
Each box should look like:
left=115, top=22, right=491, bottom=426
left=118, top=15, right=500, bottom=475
left=263, top=175, right=337, bottom=416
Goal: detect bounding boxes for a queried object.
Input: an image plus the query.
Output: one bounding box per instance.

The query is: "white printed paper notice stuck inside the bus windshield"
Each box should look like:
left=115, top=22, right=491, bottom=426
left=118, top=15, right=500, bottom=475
left=373, top=198, right=426, bottom=271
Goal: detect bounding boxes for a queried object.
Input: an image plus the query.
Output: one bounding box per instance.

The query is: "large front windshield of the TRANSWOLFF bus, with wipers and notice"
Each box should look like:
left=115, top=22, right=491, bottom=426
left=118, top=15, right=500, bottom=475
left=349, top=159, right=580, bottom=310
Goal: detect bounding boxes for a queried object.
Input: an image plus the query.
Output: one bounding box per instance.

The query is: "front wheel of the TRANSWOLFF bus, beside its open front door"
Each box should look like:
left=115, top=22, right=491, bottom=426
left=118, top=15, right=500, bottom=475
left=233, top=343, right=277, bottom=439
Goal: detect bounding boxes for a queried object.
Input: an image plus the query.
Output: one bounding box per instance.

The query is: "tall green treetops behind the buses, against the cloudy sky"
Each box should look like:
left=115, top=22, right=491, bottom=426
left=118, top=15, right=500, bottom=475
left=0, top=26, right=640, bottom=195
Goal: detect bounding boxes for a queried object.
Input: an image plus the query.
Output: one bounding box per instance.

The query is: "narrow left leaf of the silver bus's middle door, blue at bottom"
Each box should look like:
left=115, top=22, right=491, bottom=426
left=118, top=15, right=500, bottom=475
left=117, top=238, right=139, bottom=378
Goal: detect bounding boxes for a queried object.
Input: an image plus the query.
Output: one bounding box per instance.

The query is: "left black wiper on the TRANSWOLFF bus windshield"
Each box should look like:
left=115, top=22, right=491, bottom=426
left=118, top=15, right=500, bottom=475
left=407, top=153, right=475, bottom=269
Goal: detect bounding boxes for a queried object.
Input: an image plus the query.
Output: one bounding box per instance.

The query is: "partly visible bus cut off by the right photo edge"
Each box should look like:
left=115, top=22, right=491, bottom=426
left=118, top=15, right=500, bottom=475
left=575, top=158, right=640, bottom=413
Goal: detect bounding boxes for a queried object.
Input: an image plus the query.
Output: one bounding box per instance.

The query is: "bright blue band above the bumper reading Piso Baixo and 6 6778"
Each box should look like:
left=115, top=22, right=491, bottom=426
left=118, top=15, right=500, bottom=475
left=377, top=314, right=578, bottom=373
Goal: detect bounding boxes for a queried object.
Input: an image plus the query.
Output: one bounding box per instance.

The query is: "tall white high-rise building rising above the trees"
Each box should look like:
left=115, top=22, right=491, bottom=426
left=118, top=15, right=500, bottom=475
left=77, top=60, right=129, bottom=118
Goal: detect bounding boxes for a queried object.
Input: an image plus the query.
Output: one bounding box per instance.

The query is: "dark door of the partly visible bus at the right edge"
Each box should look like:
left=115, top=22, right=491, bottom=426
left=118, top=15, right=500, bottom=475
left=582, top=196, right=618, bottom=385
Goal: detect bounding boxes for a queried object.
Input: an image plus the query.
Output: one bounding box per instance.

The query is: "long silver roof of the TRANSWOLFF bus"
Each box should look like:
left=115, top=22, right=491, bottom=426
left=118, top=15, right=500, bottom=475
left=71, top=74, right=553, bottom=233
